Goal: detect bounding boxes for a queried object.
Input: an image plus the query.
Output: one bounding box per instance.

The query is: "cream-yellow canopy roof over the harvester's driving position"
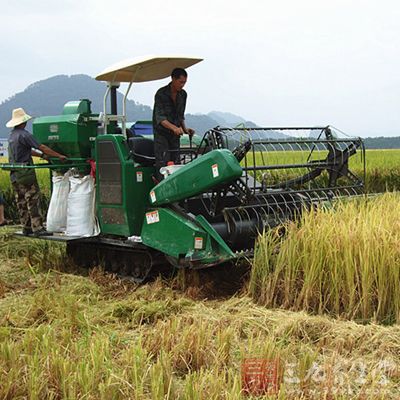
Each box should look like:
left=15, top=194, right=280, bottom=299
left=96, top=56, right=203, bottom=82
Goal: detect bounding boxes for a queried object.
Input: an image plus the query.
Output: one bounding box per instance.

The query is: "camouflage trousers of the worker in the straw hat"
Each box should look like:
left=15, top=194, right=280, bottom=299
left=13, top=182, right=43, bottom=232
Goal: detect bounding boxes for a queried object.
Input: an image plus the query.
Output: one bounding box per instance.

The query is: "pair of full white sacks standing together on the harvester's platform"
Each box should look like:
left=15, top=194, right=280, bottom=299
left=46, top=171, right=99, bottom=237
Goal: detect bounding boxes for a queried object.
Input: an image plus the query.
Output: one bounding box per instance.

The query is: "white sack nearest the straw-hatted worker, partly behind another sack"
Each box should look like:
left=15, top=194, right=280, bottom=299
left=46, top=172, right=70, bottom=232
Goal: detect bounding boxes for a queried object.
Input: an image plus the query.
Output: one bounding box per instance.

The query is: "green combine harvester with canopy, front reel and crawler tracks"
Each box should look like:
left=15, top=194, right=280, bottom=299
left=3, top=57, right=365, bottom=282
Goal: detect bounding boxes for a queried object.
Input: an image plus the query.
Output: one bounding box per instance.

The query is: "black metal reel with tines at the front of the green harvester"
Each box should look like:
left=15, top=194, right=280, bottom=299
left=186, top=126, right=365, bottom=251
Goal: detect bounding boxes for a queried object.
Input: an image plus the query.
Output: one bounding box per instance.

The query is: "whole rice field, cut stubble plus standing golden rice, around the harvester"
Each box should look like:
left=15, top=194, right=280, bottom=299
left=0, top=150, right=400, bottom=400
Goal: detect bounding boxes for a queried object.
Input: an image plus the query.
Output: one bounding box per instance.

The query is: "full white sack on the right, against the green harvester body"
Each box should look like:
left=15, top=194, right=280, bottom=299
left=66, top=175, right=98, bottom=236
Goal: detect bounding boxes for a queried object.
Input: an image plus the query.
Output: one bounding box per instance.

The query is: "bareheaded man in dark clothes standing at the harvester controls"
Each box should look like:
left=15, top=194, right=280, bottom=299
left=153, top=68, right=195, bottom=181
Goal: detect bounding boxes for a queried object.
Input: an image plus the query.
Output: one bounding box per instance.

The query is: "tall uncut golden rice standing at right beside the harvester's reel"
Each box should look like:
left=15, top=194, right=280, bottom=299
left=249, top=193, right=400, bottom=323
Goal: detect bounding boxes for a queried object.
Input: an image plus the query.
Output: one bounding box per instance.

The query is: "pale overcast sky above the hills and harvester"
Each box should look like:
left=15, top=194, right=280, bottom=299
left=0, top=0, right=400, bottom=137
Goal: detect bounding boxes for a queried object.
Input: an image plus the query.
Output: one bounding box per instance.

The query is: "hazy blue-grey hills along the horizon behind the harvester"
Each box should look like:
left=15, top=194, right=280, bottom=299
left=0, top=74, right=400, bottom=149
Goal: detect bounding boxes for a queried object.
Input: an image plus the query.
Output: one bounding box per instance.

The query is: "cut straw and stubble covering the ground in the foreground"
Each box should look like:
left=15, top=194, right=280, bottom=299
left=0, top=228, right=400, bottom=400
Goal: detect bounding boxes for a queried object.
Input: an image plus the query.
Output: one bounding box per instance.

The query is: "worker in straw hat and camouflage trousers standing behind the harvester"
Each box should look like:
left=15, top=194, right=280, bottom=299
left=6, top=108, right=67, bottom=236
